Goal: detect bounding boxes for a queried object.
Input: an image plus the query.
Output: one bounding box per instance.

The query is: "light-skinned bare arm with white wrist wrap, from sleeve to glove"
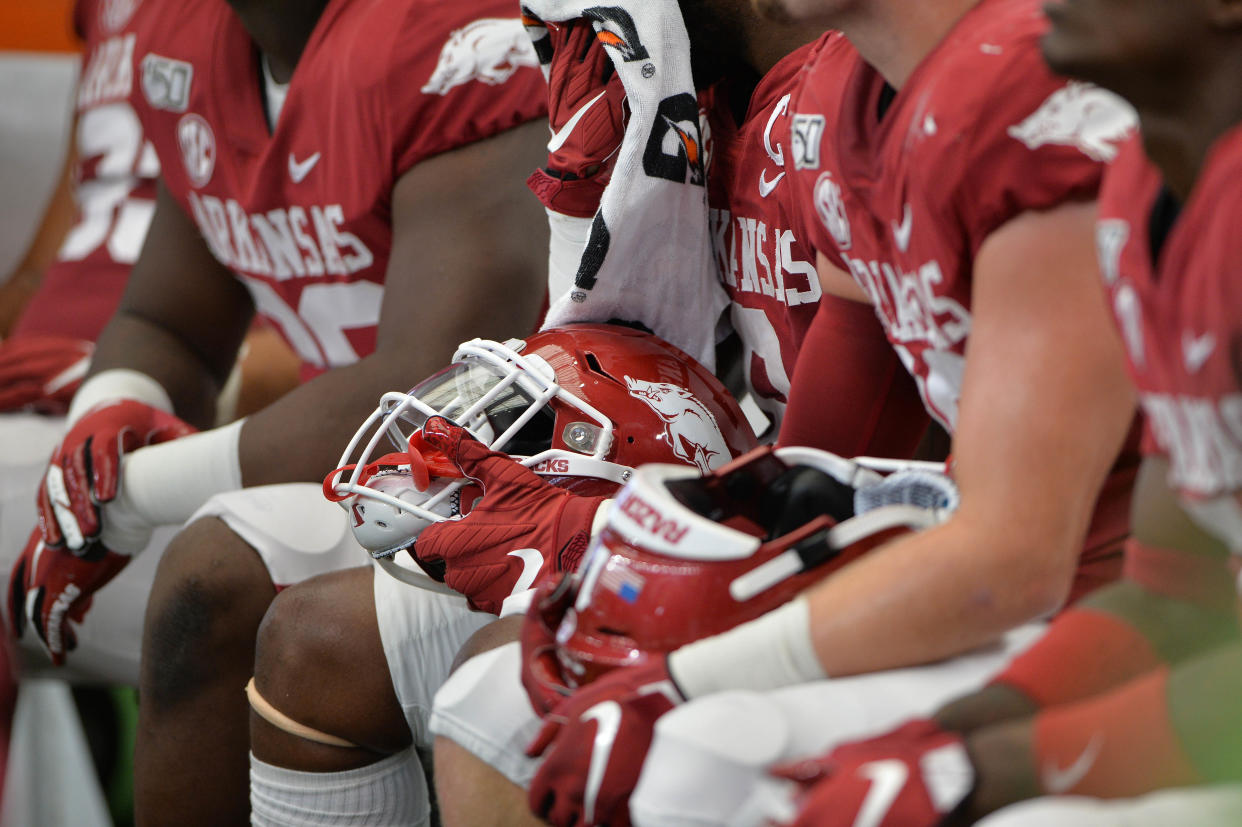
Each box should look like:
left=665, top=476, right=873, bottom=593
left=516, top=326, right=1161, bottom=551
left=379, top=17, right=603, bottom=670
left=672, top=204, right=1134, bottom=695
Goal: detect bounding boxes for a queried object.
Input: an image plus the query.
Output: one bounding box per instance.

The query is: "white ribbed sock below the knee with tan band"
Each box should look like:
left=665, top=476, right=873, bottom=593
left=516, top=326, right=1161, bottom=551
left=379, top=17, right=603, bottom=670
left=250, top=746, right=431, bottom=827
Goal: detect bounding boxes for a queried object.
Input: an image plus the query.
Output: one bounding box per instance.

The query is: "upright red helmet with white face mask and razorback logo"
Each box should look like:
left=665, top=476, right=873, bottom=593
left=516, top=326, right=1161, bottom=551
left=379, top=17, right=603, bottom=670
left=324, top=324, right=756, bottom=585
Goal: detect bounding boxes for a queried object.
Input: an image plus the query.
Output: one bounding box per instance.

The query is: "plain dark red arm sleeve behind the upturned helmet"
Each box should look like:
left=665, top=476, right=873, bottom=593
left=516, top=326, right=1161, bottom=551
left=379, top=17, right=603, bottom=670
left=779, top=289, right=929, bottom=458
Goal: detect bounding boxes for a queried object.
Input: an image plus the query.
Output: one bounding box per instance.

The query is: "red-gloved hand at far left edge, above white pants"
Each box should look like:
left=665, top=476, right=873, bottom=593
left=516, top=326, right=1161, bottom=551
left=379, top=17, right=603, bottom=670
left=0, top=334, right=94, bottom=415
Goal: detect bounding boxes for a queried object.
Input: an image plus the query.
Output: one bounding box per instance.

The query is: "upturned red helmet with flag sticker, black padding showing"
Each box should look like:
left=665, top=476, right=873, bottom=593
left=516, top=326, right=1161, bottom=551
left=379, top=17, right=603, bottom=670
left=548, top=447, right=956, bottom=687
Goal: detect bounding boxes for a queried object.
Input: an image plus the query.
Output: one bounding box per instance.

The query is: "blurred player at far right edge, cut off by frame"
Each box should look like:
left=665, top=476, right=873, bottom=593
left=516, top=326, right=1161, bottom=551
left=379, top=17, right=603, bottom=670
left=760, top=0, right=1242, bottom=827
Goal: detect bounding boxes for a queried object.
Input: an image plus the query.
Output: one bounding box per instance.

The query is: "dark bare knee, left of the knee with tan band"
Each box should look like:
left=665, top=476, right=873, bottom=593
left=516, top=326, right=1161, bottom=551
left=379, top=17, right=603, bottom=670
left=142, top=518, right=274, bottom=712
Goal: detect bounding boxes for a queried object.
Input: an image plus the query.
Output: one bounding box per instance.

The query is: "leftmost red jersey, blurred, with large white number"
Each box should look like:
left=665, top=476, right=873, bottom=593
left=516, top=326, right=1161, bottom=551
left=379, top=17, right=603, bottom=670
left=14, top=0, right=159, bottom=341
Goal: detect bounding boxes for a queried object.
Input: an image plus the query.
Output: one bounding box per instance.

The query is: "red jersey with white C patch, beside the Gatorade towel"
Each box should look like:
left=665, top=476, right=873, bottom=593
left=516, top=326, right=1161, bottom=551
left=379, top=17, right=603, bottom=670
left=703, top=47, right=820, bottom=423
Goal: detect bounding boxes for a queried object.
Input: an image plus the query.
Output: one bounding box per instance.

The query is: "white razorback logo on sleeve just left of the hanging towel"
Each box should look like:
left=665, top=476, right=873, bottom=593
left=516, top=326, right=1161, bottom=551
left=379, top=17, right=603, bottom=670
left=422, top=17, right=539, bottom=94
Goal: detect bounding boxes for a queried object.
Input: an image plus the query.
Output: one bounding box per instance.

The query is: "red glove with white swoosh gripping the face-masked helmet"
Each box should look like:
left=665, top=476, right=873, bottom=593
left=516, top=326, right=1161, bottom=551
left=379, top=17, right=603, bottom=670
left=411, top=416, right=606, bottom=615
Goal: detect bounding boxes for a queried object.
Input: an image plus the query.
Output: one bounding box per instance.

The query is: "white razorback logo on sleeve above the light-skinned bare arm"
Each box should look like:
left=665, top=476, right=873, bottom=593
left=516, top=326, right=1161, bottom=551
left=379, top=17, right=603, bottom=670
left=1009, top=82, right=1138, bottom=161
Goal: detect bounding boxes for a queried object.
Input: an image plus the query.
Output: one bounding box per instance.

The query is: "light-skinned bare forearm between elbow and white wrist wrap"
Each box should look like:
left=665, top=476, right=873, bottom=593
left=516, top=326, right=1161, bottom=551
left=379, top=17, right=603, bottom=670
left=809, top=513, right=1077, bottom=677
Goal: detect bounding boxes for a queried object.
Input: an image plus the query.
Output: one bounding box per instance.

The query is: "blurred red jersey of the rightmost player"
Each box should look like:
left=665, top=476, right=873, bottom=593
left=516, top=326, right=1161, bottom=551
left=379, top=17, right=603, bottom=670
left=1097, top=129, right=1242, bottom=548
